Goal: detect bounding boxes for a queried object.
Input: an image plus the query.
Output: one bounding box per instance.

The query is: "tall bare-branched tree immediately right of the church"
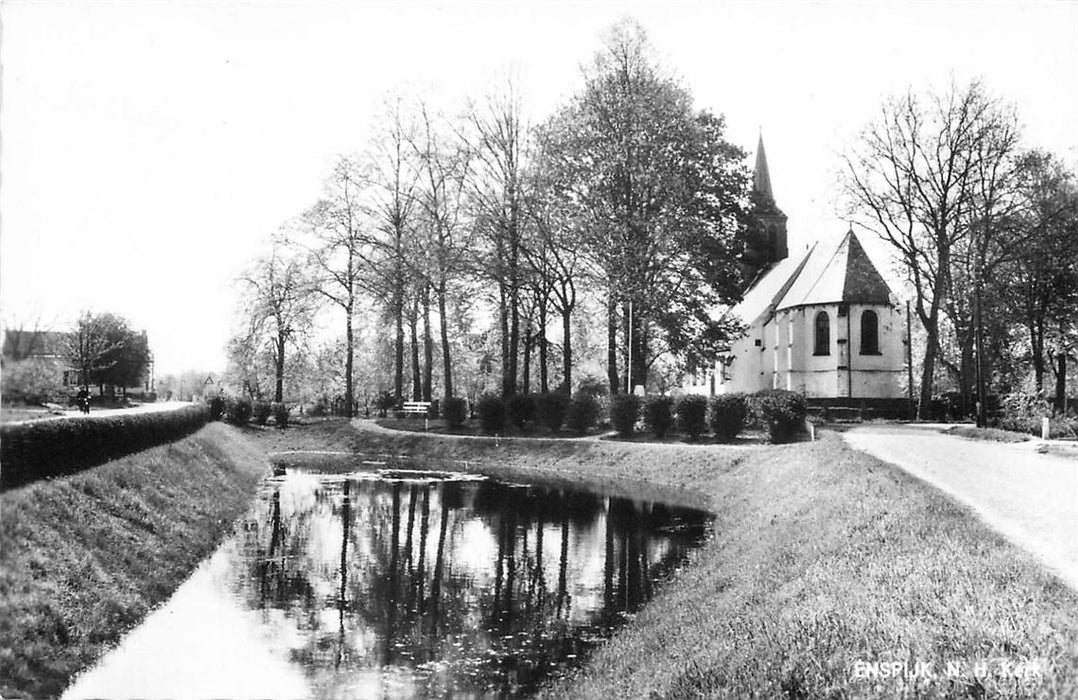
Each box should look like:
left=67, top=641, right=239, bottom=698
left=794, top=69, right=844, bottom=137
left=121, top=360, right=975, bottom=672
left=842, top=82, right=998, bottom=417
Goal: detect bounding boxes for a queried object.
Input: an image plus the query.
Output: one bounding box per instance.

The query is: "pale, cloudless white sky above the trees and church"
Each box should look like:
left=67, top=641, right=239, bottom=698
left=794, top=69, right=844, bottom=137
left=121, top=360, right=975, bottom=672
left=0, top=0, right=1078, bottom=376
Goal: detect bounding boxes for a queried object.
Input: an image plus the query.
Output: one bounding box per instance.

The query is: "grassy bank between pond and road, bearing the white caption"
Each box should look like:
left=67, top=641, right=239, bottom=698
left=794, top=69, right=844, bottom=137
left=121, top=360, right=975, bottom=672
left=254, top=422, right=1078, bottom=698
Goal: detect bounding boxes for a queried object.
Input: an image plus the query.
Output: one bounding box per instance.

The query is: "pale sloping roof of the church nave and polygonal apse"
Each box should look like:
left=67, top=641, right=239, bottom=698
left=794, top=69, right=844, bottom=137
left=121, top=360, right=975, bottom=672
left=731, top=230, right=892, bottom=324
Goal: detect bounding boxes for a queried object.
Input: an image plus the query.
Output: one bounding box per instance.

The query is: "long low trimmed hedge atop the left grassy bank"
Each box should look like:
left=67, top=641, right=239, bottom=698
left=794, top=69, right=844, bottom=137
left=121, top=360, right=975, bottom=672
left=0, top=404, right=210, bottom=490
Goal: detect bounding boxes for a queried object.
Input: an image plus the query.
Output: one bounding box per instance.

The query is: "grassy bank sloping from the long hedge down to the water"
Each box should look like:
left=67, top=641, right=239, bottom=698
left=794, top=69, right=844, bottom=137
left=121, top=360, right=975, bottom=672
left=0, top=424, right=265, bottom=698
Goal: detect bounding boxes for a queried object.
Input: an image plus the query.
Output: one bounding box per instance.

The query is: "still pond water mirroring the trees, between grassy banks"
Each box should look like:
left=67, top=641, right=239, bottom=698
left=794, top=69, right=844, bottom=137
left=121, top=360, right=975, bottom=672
left=65, top=459, right=709, bottom=698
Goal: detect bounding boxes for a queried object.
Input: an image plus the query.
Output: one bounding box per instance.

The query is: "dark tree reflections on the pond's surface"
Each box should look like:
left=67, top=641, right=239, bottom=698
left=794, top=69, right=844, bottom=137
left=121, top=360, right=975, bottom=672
left=244, top=461, right=708, bottom=697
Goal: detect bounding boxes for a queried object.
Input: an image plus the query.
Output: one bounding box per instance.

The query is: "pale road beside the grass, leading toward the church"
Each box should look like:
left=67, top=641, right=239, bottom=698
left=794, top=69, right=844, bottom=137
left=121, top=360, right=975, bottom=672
left=843, top=425, right=1078, bottom=589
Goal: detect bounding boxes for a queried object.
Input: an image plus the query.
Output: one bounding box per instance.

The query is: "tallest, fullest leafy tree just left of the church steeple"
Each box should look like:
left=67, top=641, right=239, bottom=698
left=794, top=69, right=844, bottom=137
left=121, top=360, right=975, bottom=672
left=542, top=22, right=748, bottom=390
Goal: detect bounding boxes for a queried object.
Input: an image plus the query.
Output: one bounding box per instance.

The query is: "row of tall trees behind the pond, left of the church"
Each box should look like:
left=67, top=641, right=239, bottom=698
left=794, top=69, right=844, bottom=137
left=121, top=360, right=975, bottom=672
left=230, top=22, right=749, bottom=409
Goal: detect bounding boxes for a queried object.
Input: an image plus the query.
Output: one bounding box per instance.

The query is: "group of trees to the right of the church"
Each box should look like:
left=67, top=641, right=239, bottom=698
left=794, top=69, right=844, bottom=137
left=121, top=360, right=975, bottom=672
left=842, top=81, right=1078, bottom=425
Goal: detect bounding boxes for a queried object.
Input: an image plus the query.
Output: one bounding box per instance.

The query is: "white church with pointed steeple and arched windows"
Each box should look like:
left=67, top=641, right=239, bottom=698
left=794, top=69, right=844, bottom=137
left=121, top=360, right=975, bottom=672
left=686, top=136, right=907, bottom=401
